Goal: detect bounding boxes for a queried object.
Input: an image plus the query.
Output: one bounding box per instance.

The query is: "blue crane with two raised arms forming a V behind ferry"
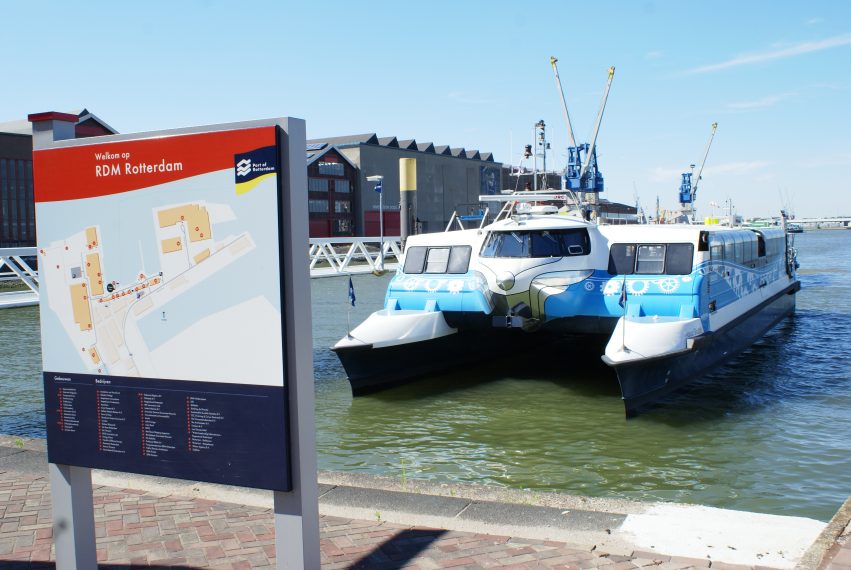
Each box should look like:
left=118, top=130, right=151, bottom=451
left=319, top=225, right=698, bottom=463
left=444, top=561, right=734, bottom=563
left=550, top=57, right=615, bottom=215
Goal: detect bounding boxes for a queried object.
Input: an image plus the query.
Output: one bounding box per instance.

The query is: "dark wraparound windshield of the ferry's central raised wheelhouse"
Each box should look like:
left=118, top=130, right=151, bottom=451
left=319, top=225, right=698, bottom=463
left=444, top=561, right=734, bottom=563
left=481, top=228, right=591, bottom=257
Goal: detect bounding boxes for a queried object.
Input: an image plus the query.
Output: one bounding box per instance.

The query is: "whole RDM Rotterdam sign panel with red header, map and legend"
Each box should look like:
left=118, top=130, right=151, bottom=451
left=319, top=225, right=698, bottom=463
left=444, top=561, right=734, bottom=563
left=34, top=126, right=292, bottom=491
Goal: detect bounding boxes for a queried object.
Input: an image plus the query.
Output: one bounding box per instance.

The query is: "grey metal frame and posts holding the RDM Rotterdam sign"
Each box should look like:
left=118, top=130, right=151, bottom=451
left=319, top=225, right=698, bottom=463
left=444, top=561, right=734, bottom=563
left=31, top=114, right=319, bottom=569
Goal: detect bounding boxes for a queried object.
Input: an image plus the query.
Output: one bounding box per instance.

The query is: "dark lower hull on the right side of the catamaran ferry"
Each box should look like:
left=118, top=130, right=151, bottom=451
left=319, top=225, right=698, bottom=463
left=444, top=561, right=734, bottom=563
left=603, top=281, right=801, bottom=417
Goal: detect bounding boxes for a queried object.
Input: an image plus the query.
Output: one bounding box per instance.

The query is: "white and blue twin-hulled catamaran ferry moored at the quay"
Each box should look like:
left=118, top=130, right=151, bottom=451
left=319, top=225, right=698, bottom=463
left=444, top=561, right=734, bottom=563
left=333, top=193, right=800, bottom=415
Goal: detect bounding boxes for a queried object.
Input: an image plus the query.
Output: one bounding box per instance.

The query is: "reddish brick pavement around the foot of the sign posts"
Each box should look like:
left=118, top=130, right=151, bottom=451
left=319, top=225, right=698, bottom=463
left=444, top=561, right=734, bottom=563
left=0, top=472, right=764, bottom=570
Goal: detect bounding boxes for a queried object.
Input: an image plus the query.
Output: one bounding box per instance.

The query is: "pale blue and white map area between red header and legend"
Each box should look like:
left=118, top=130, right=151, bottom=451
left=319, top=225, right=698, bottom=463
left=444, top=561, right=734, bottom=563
left=38, top=143, right=284, bottom=386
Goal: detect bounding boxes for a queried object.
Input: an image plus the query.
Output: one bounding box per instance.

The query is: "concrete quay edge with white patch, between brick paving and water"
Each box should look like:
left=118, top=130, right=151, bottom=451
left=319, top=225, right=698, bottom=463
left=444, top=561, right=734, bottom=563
left=0, top=436, right=848, bottom=570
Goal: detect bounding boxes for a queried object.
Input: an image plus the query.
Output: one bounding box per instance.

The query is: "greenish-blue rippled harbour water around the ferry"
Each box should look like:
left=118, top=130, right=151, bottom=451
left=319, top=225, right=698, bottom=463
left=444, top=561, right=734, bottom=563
left=0, top=231, right=851, bottom=520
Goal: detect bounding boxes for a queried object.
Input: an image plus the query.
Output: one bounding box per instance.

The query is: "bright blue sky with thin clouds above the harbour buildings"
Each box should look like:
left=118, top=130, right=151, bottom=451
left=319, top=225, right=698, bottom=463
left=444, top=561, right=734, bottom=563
left=0, top=0, right=851, bottom=216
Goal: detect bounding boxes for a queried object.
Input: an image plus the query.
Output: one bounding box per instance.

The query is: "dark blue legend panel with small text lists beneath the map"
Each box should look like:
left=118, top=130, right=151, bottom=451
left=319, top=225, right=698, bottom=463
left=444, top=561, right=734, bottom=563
left=44, top=372, right=292, bottom=491
